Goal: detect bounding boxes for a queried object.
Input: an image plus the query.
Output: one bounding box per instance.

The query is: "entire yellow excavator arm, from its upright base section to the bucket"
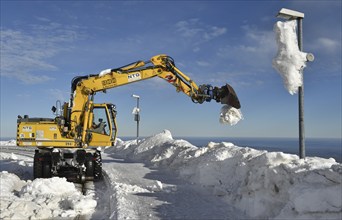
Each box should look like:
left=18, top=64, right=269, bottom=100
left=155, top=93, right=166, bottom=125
left=67, top=54, right=241, bottom=139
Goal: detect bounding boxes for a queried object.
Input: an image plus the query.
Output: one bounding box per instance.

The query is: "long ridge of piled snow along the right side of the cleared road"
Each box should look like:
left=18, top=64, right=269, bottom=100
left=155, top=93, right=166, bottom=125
left=106, top=130, right=342, bottom=219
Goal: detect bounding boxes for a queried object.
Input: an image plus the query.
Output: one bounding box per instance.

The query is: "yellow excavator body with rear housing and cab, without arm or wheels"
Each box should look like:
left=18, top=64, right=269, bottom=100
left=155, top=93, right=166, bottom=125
left=17, top=103, right=117, bottom=148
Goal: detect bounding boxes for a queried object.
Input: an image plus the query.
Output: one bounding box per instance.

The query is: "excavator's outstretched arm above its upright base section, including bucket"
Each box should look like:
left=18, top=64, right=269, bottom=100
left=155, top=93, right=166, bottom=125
left=72, top=55, right=241, bottom=106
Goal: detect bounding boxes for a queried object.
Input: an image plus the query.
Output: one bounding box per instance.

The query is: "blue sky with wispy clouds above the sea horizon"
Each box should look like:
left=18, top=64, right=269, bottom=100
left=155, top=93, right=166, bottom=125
left=1, top=1, right=342, bottom=138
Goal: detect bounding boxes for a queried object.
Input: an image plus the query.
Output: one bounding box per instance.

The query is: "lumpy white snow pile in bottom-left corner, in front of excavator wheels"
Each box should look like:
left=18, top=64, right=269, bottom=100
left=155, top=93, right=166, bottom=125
left=0, top=171, right=96, bottom=219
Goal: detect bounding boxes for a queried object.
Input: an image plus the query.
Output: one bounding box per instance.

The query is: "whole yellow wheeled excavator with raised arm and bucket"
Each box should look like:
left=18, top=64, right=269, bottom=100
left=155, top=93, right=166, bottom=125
left=17, top=54, right=241, bottom=182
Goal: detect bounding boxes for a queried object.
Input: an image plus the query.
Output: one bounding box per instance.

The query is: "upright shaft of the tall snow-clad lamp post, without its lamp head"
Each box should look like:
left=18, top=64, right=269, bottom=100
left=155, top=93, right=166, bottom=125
left=297, top=18, right=305, bottom=159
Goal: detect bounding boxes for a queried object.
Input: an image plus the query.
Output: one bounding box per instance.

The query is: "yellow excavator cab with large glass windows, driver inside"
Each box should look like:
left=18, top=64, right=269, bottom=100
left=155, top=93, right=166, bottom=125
left=87, top=104, right=117, bottom=146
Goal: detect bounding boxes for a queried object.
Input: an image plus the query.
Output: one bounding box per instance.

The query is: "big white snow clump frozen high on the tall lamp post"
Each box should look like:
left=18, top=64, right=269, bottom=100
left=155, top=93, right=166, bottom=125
left=273, top=20, right=307, bottom=95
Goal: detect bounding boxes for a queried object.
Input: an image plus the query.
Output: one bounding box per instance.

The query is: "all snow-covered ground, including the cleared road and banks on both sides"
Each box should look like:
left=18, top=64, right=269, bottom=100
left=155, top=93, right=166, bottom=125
left=0, top=130, right=342, bottom=219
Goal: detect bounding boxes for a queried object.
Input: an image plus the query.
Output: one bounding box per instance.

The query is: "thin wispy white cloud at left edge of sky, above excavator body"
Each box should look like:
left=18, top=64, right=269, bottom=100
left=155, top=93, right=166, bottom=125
left=0, top=22, right=82, bottom=84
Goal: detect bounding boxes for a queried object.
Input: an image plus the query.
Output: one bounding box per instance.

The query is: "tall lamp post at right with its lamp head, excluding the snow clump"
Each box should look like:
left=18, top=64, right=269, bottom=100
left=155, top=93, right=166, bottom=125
left=277, top=8, right=313, bottom=159
